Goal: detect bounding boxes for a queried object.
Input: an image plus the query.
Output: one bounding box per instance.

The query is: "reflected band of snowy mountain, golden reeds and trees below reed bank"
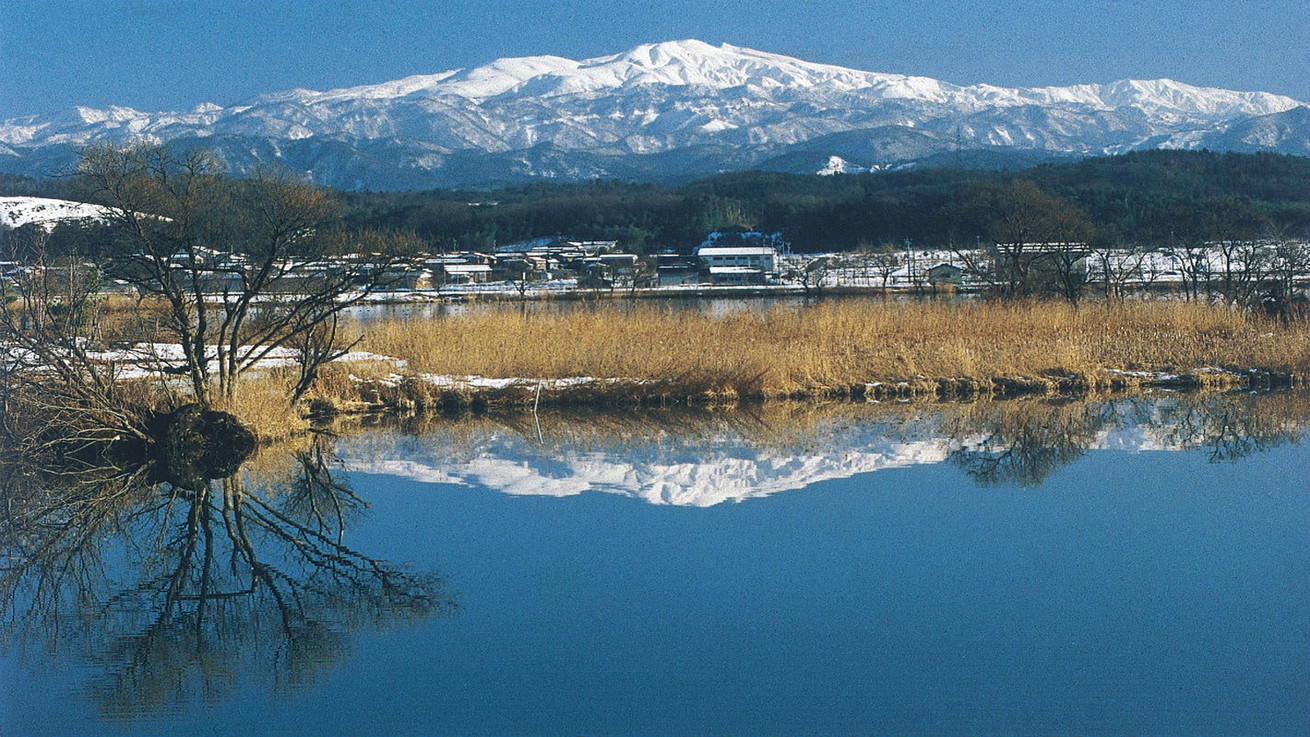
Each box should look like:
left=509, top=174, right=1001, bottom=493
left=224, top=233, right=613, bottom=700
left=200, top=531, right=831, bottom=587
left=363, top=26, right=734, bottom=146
left=338, top=393, right=1310, bottom=507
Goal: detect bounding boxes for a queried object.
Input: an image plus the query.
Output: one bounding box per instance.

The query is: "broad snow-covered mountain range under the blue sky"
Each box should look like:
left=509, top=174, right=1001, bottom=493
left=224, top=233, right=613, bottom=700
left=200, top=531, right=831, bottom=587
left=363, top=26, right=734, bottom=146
left=0, top=41, right=1310, bottom=189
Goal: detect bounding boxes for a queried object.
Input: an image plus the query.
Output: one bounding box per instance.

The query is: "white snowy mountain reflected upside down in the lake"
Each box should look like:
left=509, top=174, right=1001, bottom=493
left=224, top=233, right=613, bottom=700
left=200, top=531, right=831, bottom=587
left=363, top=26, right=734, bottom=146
left=338, top=416, right=974, bottom=507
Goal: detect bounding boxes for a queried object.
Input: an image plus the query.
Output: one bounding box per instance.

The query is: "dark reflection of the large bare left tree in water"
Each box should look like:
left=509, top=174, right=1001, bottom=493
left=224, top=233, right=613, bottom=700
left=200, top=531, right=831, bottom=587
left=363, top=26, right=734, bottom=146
left=0, top=439, right=452, bottom=717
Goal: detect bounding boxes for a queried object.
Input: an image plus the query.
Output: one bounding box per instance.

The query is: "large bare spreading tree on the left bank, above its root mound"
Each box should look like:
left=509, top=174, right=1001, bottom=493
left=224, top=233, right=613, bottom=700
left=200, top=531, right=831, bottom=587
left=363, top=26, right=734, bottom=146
left=79, top=144, right=417, bottom=406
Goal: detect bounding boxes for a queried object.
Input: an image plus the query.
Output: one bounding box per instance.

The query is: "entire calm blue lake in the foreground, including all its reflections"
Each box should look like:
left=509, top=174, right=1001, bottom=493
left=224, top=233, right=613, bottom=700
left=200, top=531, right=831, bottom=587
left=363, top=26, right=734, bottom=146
left=0, top=393, right=1310, bottom=736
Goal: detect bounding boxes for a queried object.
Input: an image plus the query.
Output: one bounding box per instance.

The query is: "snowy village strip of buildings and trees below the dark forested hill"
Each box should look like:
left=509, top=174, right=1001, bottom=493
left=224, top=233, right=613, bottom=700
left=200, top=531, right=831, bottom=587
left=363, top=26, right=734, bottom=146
left=0, top=225, right=1310, bottom=301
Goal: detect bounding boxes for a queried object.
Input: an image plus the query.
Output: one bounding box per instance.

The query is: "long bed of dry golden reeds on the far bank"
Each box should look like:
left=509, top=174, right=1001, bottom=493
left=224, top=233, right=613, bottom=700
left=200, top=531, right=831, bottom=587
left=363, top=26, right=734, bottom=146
left=321, top=300, right=1310, bottom=407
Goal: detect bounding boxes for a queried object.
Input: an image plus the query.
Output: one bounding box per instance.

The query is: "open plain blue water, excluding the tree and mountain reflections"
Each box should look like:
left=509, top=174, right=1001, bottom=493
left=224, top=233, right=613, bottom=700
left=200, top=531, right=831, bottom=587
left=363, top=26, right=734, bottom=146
left=0, top=400, right=1310, bottom=736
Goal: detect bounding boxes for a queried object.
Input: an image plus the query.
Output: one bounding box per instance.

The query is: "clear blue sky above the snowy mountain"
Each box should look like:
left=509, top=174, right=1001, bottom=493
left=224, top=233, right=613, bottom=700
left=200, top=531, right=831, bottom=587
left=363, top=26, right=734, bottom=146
left=0, top=0, right=1310, bottom=119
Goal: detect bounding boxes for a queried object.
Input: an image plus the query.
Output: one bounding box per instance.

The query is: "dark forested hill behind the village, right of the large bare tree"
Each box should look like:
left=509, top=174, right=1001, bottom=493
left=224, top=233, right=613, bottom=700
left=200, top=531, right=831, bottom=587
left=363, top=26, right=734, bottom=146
left=342, top=151, right=1310, bottom=251
